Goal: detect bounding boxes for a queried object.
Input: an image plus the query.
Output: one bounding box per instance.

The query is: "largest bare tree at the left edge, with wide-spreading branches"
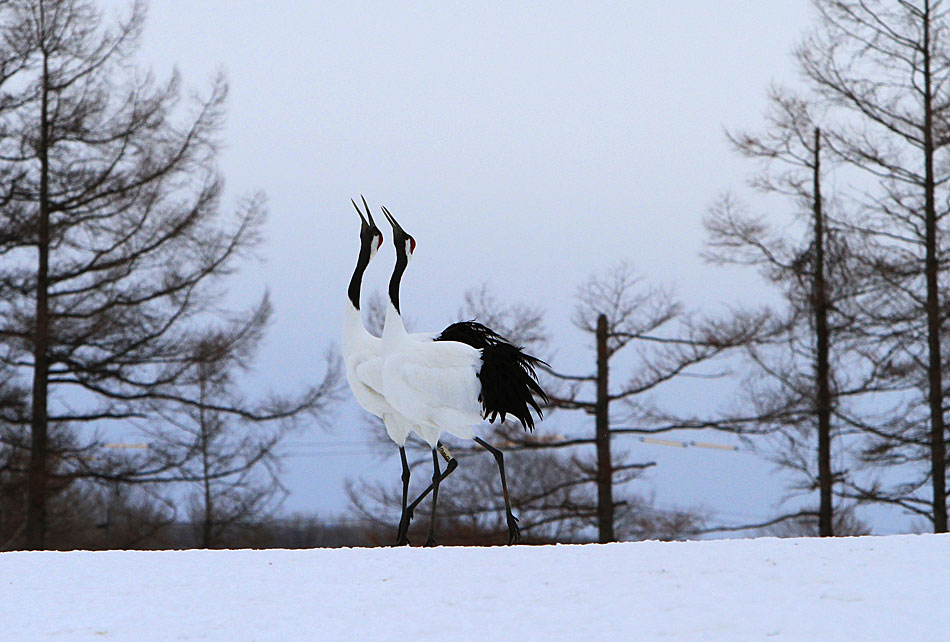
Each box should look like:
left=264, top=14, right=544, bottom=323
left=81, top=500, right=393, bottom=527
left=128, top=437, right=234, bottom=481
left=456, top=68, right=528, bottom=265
left=0, top=0, right=342, bottom=548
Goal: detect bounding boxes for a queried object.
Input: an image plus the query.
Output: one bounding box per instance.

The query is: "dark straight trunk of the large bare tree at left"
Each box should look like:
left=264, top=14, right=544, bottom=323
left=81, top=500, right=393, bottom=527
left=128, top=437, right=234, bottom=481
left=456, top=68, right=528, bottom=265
left=25, top=51, right=50, bottom=550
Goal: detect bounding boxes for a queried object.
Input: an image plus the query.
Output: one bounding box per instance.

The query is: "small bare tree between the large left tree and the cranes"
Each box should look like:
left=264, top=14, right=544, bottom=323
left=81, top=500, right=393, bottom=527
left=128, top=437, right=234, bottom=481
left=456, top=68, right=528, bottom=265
left=144, top=297, right=341, bottom=548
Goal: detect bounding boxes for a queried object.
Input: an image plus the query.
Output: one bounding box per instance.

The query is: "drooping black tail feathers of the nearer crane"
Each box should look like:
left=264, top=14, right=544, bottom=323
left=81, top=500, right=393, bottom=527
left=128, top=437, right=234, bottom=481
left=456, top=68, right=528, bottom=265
left=435, top=321, right=548, bottom=430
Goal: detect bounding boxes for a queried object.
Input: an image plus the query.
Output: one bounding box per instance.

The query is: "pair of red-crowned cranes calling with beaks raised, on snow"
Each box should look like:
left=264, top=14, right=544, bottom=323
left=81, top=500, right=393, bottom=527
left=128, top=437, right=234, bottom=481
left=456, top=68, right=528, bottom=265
left=342, top=198, right=547, bottom=546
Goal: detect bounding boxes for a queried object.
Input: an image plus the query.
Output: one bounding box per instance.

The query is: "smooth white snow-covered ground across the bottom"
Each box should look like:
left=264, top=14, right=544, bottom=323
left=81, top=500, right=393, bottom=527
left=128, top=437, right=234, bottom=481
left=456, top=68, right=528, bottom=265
left=0, top=535, right=950, bottom=642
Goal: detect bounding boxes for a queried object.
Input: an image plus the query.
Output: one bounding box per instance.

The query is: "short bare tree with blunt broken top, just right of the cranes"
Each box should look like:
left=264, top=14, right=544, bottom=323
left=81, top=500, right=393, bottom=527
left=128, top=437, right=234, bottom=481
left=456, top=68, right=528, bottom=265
left=506, top=264, right=764, bottom=542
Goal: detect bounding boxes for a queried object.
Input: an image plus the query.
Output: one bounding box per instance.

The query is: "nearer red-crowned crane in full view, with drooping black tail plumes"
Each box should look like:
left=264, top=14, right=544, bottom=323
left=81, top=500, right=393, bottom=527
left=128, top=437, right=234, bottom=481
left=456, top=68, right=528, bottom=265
left=381, top=207, right=547, bottom=546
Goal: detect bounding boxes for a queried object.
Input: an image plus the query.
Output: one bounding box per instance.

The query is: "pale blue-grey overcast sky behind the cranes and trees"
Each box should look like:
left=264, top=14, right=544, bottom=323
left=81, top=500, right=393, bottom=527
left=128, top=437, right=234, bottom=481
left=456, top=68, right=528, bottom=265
left=122, top=0, right=920, bottom=532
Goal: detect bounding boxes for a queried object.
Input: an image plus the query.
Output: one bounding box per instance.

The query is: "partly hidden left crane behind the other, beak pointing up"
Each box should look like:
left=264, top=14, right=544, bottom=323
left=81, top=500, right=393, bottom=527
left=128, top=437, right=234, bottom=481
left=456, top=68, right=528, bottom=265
left=341, top=198, right=420, bottom=545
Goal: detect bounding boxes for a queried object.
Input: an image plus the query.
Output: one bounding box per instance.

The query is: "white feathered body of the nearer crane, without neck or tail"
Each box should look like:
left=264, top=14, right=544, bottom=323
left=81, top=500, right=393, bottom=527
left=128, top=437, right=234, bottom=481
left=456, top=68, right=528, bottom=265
left=380, top=302, right=482, bottom=448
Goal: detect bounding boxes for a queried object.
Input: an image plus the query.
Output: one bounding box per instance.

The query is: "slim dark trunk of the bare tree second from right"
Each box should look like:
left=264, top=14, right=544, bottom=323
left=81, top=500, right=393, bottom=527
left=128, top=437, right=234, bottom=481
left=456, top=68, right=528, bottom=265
left=812, top=128, right=834, bottom=537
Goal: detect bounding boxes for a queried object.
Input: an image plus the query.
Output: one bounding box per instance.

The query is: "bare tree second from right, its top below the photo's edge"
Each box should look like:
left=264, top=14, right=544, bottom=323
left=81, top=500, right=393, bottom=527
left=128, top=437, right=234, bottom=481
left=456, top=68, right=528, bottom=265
left=706, top=89, right=887, bottom=536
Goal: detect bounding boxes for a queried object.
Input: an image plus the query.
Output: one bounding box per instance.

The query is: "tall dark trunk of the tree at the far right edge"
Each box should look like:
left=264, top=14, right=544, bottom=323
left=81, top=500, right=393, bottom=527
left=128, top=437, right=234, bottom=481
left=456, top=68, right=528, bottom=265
left=923, top=2, right=947, bottom=533
